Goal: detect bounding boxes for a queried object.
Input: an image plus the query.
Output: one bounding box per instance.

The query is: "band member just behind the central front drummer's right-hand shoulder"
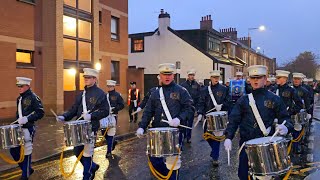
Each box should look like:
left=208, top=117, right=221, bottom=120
left=180, top=69, right=200, bottom=143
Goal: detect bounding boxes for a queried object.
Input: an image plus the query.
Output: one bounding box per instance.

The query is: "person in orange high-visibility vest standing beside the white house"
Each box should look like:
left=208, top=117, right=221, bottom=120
left=128, top=81, right=140, bottom=123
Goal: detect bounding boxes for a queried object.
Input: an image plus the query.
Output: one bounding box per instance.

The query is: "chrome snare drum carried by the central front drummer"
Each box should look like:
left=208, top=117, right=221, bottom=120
left=147, top=127, right=179, bottom=157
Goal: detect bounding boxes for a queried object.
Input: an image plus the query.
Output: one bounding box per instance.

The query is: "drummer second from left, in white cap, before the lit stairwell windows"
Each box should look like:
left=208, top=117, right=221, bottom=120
left=57, top=68, right=109, bottom=180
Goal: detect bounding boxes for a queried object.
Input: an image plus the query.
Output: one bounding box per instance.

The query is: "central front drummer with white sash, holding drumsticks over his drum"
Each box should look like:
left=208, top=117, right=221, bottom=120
left=137, top=63, right=195, bottom=180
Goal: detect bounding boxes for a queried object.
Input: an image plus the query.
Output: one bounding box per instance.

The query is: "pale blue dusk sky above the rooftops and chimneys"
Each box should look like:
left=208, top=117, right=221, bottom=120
left=129, top=0, right=320, bottom=64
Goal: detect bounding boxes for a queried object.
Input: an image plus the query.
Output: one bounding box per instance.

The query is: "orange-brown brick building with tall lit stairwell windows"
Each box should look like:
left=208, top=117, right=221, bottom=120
left=0, top=0, right=128, bottom=119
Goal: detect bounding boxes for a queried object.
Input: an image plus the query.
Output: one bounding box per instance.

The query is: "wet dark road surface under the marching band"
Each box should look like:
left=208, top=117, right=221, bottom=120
left=0, top=98, right=320, bottom=180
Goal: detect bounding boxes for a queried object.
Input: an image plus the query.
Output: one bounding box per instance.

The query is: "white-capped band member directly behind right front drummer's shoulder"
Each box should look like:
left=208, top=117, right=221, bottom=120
left=274, top=70, right=303, bottom=115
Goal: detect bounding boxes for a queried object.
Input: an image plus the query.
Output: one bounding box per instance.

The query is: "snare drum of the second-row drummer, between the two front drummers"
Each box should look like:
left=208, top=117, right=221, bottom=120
left=206, top=111, right=228, bottom=132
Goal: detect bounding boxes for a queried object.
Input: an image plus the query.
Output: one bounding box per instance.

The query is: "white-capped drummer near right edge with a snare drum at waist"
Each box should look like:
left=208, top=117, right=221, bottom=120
left=292, top=73, right=312, bottom=153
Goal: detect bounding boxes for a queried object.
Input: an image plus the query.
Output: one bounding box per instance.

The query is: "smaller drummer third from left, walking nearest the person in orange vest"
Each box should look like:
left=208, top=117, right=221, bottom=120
left=101, top=80, right=124, bottom=158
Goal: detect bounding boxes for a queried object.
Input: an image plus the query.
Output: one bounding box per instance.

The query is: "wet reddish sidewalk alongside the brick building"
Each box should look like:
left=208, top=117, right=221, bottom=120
left=0, top=108, right=141, bottom=172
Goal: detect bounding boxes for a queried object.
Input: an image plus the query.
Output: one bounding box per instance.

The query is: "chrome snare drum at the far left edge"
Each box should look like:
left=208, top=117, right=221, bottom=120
left=0, top=124, right=23, bottom=149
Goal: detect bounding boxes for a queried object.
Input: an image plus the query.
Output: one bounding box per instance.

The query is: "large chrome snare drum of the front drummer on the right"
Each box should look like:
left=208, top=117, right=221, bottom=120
left=245, top=136, right=291, bottom=176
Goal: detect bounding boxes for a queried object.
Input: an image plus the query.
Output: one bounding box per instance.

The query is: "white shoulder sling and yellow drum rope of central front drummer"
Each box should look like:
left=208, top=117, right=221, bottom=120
left=148, top=87, right=181, bottom=180
